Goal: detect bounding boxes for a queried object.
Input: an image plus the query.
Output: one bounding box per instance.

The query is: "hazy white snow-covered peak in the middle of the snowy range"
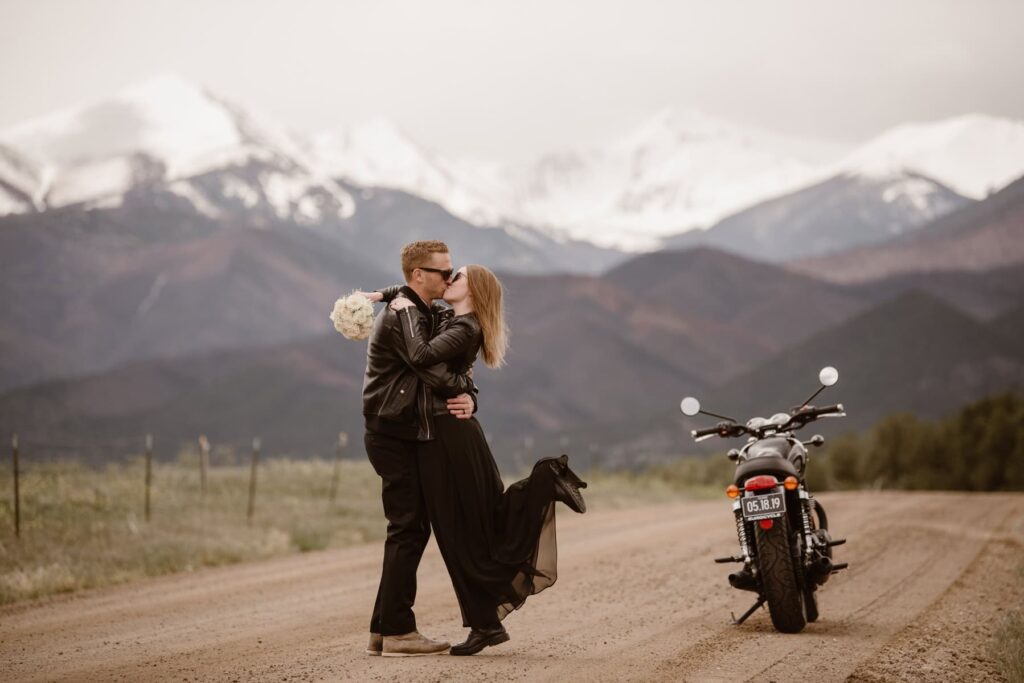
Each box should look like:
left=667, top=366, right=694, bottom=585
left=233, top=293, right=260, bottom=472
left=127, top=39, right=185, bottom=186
left=507, top=110, right=816, bottom=250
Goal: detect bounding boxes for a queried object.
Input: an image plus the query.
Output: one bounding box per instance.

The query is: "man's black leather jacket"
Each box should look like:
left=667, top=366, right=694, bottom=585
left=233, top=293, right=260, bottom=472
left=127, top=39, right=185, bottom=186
left=362, top=287, right=474, bottom=441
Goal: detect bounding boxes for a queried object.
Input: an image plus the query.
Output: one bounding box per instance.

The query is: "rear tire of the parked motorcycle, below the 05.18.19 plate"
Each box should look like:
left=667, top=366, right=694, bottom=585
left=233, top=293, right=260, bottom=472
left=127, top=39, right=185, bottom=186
left=754, top=515, right=807, bottom=633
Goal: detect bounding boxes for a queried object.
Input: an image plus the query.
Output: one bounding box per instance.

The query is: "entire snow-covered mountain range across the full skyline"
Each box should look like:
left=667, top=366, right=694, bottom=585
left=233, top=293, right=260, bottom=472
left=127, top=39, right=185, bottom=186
left=0, top=76, right=1024, bottom=258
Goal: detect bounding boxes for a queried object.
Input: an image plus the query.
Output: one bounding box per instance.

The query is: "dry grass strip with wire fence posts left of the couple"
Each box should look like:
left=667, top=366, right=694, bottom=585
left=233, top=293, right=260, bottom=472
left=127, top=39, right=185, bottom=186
left=0, top=432, right=395, bottom=605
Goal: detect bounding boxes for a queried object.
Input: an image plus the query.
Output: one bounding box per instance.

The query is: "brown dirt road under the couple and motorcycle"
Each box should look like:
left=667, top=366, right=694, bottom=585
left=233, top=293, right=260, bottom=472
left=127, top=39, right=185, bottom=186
left=0, top=493, right=1024, bottom=681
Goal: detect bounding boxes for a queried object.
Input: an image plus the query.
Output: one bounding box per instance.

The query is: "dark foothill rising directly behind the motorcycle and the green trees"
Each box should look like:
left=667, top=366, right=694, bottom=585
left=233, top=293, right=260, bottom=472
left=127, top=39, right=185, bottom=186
left=594, top=291, right=1024, bottom=467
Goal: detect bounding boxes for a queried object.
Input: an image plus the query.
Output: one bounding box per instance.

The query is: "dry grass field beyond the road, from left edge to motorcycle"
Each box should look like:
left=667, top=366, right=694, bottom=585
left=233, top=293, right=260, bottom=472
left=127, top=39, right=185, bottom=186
left=0, top=454, right=730, bottom=604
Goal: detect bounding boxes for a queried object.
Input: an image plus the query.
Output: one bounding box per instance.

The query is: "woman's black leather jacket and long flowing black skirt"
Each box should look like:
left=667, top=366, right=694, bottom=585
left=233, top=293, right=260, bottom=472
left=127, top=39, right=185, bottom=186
left=395, top=308, right=566, bottom=629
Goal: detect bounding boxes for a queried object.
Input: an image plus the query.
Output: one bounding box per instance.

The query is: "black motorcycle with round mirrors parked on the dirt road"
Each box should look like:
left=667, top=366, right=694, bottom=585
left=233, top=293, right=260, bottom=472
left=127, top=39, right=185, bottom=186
left=680, top=367, right=848, bottom=633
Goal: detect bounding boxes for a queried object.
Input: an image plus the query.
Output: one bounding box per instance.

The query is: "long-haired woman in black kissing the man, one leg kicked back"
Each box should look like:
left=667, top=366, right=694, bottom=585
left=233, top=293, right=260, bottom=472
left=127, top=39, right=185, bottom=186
left=378, top=265, right=587, bottom=655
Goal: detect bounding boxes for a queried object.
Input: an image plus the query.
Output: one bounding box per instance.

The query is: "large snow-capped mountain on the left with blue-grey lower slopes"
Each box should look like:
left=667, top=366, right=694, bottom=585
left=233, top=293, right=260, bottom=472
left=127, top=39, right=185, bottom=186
left=0, top=76, right=621, bottom=280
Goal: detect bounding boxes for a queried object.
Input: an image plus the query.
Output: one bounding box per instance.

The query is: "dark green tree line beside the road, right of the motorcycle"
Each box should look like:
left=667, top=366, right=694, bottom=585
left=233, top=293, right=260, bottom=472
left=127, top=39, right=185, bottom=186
left=807, top=393, right=1024, bottom=490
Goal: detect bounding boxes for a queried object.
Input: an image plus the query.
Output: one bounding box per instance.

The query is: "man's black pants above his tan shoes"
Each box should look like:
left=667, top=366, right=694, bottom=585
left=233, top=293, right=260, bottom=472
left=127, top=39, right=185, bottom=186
left=365, top=432, right=430, bottom=636
